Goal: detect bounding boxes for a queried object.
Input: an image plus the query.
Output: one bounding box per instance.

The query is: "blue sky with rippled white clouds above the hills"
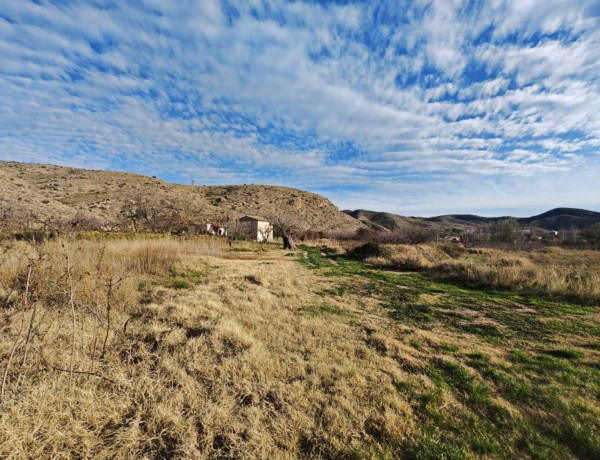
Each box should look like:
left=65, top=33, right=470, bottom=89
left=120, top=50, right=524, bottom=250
left=0, top=0, right=600, bottom=216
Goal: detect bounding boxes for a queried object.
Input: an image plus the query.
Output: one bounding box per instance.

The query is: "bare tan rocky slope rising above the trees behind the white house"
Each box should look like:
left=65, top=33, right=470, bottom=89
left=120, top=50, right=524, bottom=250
left=0, top=161, right=363, bottom=232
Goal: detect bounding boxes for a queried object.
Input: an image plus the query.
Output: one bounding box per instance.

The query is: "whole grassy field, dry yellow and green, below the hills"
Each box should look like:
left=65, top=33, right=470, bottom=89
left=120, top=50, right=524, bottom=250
left=0, top=235, right=600, bottom=459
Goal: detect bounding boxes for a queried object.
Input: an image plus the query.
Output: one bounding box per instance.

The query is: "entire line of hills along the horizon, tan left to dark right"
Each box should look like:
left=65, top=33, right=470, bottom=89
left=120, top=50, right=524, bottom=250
left=0, top=161, right=600, bottom=233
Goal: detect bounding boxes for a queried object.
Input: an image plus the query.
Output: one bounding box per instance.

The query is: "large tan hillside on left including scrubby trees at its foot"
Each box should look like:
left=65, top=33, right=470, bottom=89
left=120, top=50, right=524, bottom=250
left=0, top=161, right=362, bottom=234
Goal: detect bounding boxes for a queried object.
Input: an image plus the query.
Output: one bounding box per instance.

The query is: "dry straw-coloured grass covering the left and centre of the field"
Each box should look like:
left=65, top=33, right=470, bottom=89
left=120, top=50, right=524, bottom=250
left=0, top=240, right=419, bottom=458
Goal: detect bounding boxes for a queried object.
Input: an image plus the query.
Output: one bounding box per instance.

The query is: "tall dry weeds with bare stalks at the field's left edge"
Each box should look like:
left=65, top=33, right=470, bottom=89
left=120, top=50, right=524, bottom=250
left=0, top=240, right=197, bottom=406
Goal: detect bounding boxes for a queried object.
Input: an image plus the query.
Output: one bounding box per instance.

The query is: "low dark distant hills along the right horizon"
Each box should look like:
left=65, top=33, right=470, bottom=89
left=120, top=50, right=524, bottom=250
left=344, top=208, right=600, bottom=230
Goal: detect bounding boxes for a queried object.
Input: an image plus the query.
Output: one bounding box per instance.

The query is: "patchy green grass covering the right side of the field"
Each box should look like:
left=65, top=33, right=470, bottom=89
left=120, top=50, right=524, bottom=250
left=294, top=244, right=600, bottom=459
